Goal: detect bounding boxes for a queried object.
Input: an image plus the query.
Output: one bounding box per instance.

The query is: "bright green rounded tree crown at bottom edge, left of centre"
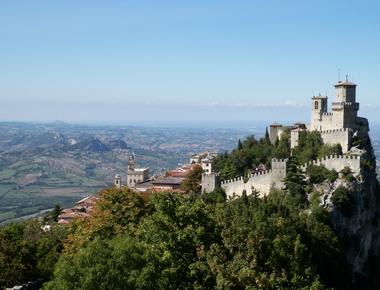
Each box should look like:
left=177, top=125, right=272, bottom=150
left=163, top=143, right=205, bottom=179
left=44, top=236, right=161, bottom=290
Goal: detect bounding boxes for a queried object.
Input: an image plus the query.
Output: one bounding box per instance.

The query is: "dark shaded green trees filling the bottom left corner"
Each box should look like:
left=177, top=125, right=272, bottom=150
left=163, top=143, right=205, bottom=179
left=0, top=220, right=67, bottom=289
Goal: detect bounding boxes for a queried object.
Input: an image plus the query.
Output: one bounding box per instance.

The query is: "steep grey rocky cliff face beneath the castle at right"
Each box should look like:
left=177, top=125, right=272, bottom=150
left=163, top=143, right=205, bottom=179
left=318, top=135, right=380, bottom=289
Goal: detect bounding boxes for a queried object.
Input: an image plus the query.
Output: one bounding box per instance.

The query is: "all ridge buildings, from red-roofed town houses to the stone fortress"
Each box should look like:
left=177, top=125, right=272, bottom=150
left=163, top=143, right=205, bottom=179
left=59, top=79, right=369, bottom=224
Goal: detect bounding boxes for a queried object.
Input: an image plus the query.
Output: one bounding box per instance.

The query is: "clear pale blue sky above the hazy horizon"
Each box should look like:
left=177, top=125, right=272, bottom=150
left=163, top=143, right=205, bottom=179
left=0, top=0, right=380, bottom=122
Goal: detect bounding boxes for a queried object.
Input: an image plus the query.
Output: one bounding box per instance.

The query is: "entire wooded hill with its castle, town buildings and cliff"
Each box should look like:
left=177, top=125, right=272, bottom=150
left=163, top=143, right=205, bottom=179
left=4, top=79, right=380, bottom=290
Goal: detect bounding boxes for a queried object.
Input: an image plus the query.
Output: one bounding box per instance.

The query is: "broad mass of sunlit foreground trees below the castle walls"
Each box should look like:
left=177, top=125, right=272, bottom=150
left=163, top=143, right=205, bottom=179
left=45, top=189, right=346, bottom=289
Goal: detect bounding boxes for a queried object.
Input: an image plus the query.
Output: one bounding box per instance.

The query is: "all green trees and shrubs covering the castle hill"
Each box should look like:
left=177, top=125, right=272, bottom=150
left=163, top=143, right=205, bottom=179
left=0, top=133, right=380, bottom=289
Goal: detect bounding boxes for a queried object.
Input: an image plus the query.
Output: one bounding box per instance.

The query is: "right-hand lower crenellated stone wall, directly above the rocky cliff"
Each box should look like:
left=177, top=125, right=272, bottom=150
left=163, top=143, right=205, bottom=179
left=301, top=155, right=360, bottom=174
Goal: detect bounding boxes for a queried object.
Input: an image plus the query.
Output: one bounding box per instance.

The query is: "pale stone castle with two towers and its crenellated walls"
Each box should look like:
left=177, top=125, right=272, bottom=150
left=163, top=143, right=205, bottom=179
left=202, top=78, right=368, bottom=198
